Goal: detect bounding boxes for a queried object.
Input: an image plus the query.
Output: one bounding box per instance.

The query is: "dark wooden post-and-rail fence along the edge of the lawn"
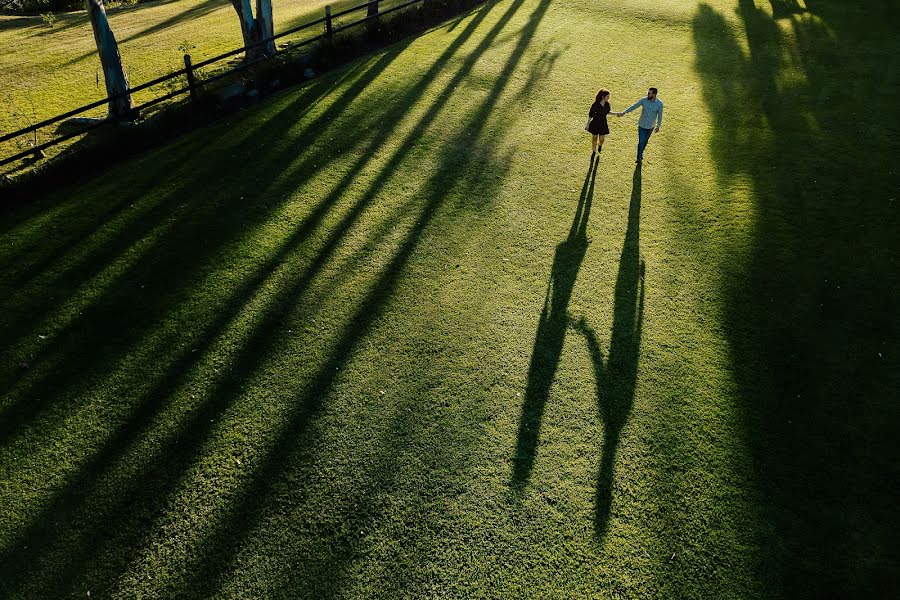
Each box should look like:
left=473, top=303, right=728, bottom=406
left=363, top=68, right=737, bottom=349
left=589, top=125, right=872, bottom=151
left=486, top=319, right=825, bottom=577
left=0, top=0, right=424, bottom=166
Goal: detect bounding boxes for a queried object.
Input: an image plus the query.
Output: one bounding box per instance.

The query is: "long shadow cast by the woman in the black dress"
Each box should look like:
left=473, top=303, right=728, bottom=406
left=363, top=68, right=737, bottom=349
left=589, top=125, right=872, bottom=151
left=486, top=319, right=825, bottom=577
left=512, top=157, right=600, bottom=489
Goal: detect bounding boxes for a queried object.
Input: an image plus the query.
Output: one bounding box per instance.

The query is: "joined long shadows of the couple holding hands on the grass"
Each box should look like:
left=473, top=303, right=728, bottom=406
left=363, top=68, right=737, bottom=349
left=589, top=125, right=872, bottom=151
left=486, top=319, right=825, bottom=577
left=512, top=157, right=644, bottom=538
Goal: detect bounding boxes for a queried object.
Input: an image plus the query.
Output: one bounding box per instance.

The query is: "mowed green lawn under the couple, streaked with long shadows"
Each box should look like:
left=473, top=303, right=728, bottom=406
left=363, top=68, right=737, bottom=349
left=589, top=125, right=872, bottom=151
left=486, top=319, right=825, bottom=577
left=0, top=0, right=900, bottom=599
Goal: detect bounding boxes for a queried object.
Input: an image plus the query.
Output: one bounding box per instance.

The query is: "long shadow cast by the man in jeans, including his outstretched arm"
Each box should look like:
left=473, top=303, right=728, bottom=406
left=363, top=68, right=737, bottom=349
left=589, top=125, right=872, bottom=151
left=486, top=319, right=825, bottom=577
left=574, top=165, right=645, bottom=539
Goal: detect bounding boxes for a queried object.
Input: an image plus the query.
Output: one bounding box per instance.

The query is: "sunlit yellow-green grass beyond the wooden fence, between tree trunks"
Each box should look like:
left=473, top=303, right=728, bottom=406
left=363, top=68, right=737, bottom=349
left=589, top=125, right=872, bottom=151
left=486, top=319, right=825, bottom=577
left=0, top=0, right=399, bottom=156
